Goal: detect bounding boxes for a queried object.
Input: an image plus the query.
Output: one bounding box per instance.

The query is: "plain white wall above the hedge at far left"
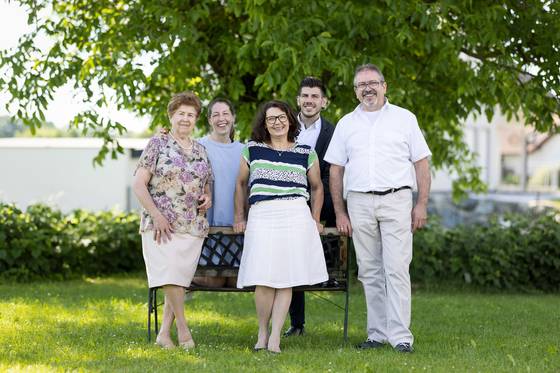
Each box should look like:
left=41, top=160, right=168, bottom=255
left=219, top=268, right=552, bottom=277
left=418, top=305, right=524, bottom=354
left=0, top=139, right=148, bottom=211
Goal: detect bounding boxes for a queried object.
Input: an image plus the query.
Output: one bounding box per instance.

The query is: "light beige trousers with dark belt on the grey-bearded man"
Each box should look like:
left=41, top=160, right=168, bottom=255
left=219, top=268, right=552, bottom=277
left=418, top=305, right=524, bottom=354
left=347, top=189, right=414, bottom=347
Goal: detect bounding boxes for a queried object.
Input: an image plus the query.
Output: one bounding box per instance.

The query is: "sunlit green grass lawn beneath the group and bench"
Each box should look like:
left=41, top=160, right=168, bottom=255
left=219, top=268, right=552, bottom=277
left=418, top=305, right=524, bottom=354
left=0, top=275, right=560, bottom=372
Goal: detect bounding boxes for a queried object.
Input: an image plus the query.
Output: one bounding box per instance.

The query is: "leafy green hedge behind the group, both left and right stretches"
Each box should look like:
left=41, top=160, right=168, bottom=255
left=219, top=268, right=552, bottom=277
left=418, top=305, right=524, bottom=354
left=0, top=203, right=560, bottom=292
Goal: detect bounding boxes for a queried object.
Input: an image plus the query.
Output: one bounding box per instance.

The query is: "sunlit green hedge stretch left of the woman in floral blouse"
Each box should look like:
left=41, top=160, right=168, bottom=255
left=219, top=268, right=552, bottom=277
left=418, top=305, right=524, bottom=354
left=0, top=204, right=143, bottom=281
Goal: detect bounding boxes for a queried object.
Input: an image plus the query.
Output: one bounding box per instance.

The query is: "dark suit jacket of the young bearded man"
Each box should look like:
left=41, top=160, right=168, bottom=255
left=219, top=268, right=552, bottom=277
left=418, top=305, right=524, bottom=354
left=315, top=116, right=336, bottom=227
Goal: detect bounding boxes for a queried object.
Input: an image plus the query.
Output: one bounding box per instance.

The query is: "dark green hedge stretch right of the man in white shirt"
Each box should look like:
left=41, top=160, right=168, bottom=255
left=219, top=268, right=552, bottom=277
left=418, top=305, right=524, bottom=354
left=411, top=212, right=560, bottom=291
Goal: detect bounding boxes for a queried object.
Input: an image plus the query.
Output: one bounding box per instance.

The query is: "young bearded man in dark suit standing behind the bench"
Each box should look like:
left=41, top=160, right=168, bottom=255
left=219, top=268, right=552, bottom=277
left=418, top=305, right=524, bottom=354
left=284, top=76, right=336, bottom=337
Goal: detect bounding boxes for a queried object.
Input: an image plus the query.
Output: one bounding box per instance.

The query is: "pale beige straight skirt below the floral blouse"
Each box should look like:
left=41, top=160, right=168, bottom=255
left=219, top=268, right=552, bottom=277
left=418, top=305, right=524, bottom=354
left=142, top=231, right=204, bottom=288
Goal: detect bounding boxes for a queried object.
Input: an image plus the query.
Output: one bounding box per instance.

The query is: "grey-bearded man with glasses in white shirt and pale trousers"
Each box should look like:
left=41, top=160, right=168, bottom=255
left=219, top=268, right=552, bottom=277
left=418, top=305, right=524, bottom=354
left=325, top=64, right=431, bottom=352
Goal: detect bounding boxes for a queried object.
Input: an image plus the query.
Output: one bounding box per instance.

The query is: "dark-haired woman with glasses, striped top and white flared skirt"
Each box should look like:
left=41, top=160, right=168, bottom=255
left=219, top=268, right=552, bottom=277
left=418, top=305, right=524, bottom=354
left=234, top=101, right=328, bottom=353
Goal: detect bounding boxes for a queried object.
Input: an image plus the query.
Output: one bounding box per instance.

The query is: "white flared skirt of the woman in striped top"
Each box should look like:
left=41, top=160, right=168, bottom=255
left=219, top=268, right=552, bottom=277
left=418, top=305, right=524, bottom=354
left=237, top=198, right=329, bottom=289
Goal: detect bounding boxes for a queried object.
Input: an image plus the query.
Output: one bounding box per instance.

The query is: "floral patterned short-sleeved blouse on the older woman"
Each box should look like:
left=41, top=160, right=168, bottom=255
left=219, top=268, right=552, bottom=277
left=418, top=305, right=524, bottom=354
left=137, top=134, right=213, bottom=237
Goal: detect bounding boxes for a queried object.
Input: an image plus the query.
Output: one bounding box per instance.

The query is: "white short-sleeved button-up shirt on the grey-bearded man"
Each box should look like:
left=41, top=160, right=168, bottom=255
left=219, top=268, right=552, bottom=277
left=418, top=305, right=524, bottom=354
left=325, top=101, right=432, bottom=192
